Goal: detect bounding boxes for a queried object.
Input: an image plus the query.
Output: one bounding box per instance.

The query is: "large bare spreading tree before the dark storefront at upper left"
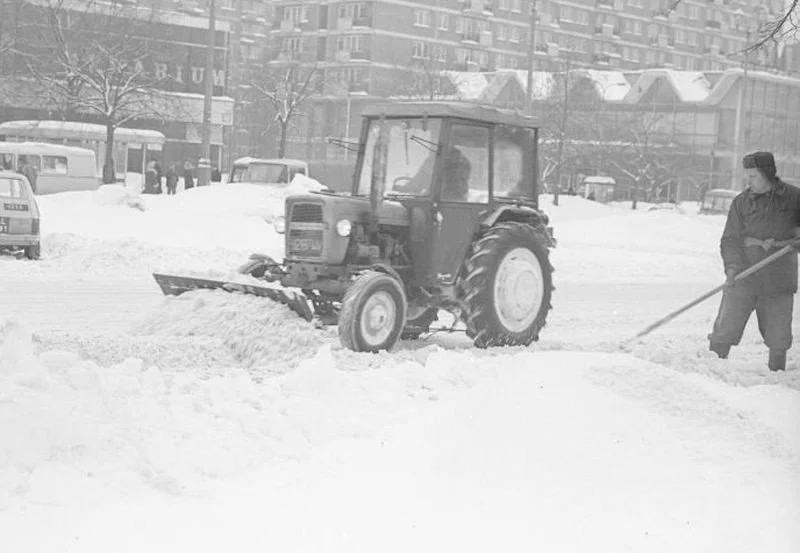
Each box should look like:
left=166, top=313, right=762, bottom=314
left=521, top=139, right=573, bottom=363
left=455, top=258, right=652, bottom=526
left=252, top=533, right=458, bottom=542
left=26, top=0, right=179, bottom=183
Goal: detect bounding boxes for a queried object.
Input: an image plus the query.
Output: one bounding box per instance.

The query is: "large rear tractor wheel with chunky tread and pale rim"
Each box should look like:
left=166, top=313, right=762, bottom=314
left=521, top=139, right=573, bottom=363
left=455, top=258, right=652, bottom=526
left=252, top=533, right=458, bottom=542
left=459, top=223, right=553, bottom=348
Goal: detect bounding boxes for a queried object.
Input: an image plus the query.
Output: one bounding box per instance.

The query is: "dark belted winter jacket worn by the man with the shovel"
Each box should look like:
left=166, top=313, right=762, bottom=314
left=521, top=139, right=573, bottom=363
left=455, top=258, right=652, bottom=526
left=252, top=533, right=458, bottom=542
left=720, top=180, right=800, bottom=296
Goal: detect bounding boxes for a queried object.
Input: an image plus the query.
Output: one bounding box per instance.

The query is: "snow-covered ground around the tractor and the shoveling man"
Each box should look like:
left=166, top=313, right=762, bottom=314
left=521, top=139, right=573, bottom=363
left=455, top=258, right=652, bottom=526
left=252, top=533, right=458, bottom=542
left=0, top=186, right=800, bottom=553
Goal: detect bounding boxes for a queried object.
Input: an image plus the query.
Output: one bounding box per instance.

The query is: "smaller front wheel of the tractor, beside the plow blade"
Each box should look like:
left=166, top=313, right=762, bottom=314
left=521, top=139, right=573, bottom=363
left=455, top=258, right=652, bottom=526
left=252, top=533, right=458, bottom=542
left=339, top=271, right=408, bottom=352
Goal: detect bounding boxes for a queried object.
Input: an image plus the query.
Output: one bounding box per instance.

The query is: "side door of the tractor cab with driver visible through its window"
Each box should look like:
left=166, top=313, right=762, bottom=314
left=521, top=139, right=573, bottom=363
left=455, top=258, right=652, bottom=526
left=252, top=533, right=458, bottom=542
left=431, top=120, right=492, bottom=284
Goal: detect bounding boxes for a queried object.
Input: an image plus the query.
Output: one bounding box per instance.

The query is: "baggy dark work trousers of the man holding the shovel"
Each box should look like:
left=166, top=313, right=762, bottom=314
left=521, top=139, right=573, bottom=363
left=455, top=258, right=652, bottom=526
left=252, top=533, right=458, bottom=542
left=708, top=283, right=794, bottom=350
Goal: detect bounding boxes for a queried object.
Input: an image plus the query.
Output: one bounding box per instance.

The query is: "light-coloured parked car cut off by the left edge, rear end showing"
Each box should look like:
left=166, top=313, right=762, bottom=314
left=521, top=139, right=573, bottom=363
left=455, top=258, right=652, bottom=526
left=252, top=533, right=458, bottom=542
left=0, top=171, right=41, bottom=259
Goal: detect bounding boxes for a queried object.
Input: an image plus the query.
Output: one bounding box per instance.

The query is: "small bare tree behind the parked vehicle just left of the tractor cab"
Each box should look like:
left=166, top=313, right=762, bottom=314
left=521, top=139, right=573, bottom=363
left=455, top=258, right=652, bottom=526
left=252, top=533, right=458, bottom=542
left=250, top=61, right=323, bottom=157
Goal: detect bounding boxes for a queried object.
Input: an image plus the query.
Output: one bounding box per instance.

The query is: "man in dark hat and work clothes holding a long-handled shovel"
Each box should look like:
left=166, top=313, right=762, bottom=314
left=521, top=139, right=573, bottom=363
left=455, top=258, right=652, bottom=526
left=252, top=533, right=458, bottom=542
left=708, top=152, right=800, bottom=371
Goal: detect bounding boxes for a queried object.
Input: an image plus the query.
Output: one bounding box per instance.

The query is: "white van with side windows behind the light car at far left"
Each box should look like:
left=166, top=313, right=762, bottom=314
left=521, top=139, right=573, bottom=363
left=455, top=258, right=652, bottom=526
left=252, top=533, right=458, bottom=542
left=0, top=142, right=100, bottom=195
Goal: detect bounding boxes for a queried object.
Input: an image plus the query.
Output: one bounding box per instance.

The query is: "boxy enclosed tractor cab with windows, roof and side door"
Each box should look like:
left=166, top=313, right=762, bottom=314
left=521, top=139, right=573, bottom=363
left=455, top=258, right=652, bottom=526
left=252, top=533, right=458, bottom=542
left=353, top=102, right=538, bottom=286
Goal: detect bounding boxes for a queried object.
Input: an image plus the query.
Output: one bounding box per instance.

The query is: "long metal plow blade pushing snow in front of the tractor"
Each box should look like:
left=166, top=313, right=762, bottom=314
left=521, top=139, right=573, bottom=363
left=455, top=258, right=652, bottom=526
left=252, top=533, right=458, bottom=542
left=153, top=273, right=314, bottom=322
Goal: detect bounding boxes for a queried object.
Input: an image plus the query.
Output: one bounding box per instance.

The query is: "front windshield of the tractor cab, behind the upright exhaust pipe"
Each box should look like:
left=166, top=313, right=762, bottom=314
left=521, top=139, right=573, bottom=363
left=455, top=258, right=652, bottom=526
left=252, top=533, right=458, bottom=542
left=358, top=117, right=442, bottom=196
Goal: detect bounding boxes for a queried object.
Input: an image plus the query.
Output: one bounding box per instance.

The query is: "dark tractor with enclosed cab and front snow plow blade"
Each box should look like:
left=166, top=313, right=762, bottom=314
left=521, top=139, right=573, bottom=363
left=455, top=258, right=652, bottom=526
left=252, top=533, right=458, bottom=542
left=154, top=102, right=556, bottom=352
